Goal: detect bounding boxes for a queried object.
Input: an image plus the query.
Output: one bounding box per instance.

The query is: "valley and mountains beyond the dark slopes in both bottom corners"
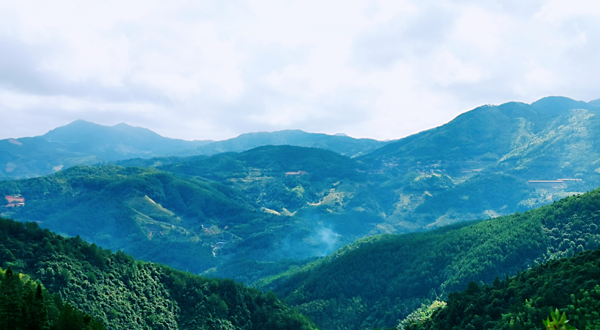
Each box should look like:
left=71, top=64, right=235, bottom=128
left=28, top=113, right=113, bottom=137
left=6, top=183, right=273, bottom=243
left=0, top=97, right=600, bottom=330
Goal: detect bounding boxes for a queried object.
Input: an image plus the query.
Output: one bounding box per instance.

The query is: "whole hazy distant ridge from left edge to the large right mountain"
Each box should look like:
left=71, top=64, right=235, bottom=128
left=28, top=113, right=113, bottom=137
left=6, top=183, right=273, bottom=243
left=0, top=120, right=387, bottom=180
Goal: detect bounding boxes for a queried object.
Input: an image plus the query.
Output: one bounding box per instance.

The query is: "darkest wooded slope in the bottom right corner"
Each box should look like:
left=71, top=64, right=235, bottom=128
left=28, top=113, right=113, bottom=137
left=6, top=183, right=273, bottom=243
left=406, top=249, right=600, bottom=330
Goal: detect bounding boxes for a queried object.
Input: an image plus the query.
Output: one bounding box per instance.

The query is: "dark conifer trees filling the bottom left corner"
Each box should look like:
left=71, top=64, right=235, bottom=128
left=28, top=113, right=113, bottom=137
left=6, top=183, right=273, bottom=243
left=0, top=268, right=105, bottom=330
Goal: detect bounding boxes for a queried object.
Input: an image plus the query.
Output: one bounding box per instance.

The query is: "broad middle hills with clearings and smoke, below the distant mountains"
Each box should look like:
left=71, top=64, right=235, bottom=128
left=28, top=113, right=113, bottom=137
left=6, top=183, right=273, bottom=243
left=0, top=139, right=596, bottom=284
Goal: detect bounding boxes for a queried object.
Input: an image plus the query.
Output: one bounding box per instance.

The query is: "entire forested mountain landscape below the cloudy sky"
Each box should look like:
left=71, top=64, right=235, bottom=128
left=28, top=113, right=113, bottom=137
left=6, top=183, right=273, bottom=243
left=0, top=97, right=600, bottom=330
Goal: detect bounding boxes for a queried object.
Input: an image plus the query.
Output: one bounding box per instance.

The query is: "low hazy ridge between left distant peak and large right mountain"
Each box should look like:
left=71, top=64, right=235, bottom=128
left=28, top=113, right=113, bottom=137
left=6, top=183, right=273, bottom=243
left=176, top=130, right=389, bottom=157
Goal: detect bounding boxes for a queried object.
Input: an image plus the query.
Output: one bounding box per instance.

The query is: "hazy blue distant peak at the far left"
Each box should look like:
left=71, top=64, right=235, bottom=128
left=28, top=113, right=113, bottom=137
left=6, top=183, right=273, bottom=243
left=0, top=120, right=212, bottom=179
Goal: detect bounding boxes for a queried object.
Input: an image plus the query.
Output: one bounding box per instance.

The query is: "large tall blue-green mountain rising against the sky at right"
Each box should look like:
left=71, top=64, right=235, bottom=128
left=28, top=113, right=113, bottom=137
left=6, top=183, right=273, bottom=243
left=360, top=97, right=600, bottom=189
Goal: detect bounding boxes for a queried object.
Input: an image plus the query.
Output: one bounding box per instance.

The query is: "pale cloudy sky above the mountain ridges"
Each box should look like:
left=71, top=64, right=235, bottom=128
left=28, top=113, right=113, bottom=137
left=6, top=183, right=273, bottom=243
left=0, top=0, right=600, bottom=140
